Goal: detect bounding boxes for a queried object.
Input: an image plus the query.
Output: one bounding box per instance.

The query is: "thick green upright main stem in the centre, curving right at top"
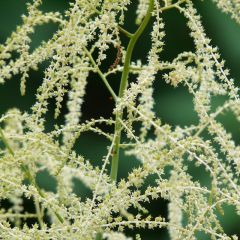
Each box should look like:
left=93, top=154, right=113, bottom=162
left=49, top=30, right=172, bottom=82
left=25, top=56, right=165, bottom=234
left=110, top=0, right=154, bottom=182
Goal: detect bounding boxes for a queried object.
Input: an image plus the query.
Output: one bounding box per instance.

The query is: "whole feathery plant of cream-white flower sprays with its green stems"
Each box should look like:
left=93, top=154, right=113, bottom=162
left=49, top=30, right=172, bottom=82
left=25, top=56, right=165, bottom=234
left=0, top=0, right=240, bottom=240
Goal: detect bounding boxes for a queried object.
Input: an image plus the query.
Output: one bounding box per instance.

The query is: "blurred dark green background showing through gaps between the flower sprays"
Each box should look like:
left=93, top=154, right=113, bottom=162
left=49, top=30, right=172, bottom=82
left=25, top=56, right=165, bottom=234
left=0, top=0, right=240, bottom=240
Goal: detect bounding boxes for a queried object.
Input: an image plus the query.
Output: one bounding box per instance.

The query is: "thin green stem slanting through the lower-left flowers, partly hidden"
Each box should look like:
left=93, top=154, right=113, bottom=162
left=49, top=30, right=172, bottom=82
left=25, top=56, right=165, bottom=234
left=0, top=128, right=64, bottom=225
